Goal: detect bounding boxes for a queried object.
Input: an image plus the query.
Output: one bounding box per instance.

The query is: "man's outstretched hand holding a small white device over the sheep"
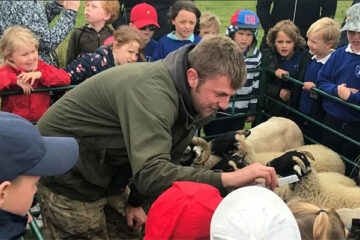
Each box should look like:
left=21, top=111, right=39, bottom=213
left=221, top=163, right=279, bottom=190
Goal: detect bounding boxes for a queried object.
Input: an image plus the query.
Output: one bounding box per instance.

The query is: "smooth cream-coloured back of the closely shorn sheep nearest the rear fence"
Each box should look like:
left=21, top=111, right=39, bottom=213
left=245, top=117, right=304, bottom=153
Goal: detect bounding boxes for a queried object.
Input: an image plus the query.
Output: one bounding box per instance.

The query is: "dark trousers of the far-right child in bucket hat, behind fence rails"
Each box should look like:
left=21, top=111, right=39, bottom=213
left=322, top=114, right=360, bottom=180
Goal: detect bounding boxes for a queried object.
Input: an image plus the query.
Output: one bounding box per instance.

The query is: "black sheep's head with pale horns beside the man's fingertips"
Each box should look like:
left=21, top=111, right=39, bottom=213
left=266, top=151, right=314, bottom=180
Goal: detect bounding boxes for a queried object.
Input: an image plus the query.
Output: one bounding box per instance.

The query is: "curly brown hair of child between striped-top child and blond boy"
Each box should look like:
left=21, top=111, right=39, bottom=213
left=266, top=20, right=306, bottom=50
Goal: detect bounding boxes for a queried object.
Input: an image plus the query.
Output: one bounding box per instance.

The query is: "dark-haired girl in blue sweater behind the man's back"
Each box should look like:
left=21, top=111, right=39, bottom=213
left=151, top=1, right=201, bottom=61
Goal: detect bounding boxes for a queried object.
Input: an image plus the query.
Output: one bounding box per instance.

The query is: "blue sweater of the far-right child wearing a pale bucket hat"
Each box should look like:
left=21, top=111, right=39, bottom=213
left=318, top=46, right=360, bottom=122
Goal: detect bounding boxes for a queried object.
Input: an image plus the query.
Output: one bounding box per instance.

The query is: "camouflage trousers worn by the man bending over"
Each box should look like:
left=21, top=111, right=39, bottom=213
left=38, top=184, right=140, bottom=240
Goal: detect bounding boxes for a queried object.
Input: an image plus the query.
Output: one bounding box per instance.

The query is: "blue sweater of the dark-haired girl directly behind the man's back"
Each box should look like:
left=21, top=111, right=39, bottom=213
left=151, top=33, right=201, bottom=62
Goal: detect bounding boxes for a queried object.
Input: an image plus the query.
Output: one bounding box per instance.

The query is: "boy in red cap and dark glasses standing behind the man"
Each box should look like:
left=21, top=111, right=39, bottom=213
left=104, top=3, right=160, bottom=62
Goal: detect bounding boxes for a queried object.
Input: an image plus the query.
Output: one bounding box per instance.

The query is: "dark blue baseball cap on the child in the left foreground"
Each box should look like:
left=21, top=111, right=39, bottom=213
left=0, top=112, right=79, bottom=183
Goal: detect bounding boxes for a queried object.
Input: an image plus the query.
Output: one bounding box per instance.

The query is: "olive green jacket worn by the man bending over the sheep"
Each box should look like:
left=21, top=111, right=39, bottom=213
left=37, top=45, right=223, bottom=201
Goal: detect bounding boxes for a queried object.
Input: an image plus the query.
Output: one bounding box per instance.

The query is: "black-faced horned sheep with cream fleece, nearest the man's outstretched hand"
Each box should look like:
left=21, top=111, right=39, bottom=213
left=267, top=152, right=360, bottom=209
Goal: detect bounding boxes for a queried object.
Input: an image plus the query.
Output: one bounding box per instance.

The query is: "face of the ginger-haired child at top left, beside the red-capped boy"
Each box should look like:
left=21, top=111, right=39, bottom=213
left=85, top=1, right=111, bottom=25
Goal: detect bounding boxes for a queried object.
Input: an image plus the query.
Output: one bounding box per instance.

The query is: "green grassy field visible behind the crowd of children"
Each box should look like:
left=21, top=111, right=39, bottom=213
left=57, top=0, right=352, bottom=66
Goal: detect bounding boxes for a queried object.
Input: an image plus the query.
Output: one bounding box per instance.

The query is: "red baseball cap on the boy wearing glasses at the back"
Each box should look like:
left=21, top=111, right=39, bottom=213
left=130, top=3, right=160, bottom=28
